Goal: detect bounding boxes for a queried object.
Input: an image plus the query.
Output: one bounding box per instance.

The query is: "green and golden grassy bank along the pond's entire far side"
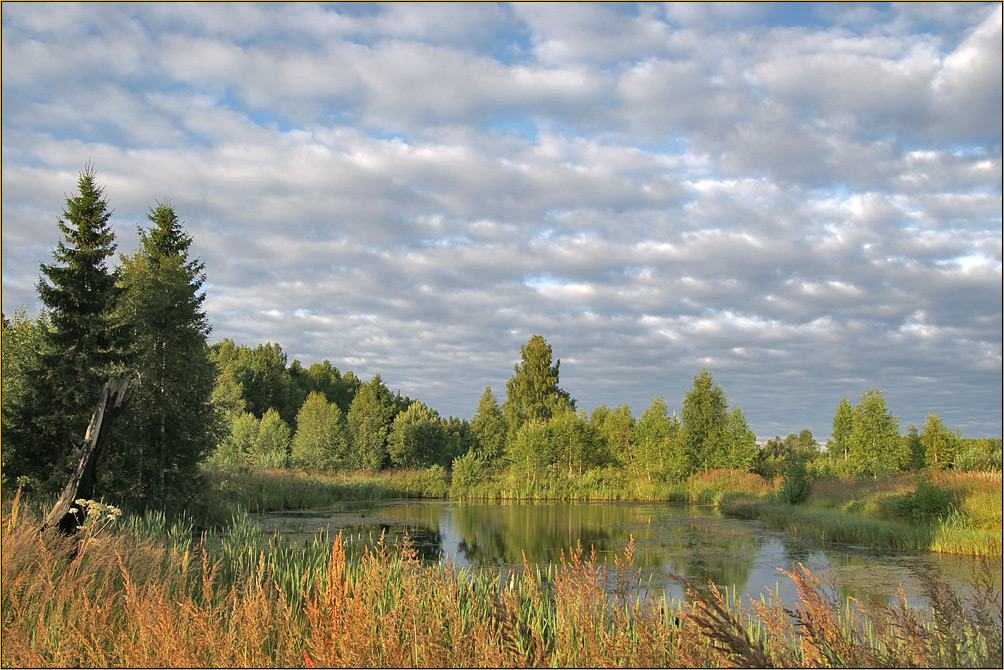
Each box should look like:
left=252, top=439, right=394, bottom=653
left=197, top=467, right=1002, bottom=556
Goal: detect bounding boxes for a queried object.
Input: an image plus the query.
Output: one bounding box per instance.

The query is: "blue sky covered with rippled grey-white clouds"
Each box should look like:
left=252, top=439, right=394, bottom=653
left=2, top=2, right=1002, bottom=439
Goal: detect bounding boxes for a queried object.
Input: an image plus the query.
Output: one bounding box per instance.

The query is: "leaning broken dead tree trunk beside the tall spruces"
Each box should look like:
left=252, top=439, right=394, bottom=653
left=42, top=379, right=130, bottom=534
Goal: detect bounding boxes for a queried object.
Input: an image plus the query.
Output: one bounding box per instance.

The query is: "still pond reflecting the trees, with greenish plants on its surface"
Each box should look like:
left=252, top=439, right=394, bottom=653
left=257, top=500, right=1001, bottom=607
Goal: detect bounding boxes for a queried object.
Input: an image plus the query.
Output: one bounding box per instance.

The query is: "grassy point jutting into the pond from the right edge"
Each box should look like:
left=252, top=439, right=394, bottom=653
left=721, top=472, right=1002, bottom=556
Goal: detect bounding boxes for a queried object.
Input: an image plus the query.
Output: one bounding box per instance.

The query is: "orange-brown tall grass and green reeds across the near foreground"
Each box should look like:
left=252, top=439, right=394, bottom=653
left=0, top=502, right=1001, bottom=667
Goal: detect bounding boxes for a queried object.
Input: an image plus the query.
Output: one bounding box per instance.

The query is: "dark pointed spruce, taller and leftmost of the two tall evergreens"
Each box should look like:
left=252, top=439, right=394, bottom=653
left=4, top=163, right=120, bottom=491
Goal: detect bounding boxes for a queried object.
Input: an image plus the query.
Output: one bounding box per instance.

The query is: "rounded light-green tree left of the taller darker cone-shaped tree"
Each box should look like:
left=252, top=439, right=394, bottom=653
left=291, top=391, right=348, bottom=470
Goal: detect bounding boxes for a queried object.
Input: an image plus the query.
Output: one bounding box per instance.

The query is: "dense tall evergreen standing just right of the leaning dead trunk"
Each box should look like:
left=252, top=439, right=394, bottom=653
left=107, top=204, right=220, bottom=501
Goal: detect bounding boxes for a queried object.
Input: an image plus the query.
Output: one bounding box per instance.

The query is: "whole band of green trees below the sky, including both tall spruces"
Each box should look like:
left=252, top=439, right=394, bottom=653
left=2, top=164, right=1000, bottom=505
